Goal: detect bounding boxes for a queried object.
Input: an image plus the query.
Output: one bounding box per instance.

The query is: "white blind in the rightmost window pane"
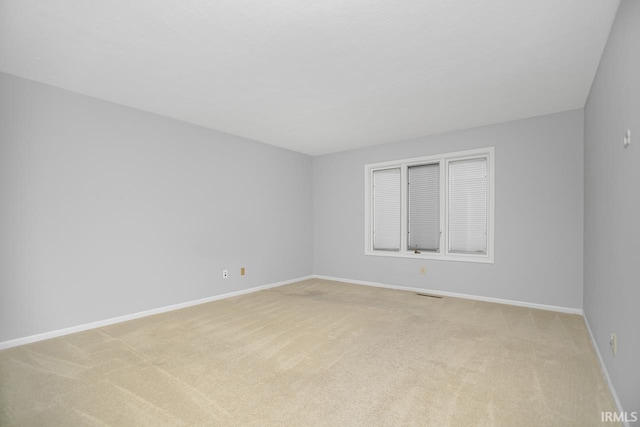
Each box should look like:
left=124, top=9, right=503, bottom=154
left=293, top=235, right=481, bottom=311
left=448, top=157, right=487, bottom=254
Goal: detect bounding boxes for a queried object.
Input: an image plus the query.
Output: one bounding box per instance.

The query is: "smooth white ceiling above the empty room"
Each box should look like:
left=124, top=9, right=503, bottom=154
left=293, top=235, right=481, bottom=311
left=0, top=0, right=619, bottom=155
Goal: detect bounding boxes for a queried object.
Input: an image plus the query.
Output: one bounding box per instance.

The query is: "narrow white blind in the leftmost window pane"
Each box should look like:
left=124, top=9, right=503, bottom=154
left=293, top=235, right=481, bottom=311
left=373, top=168, right=400, bottom=251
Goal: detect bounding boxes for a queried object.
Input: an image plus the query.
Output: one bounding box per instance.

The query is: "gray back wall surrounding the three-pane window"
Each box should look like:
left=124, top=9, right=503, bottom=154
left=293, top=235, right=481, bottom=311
left=313, top=110, right=583, bottom=308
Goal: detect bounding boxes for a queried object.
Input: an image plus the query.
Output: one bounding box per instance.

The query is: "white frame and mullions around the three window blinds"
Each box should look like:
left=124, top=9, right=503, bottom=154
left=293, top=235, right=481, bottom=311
left=364, top=147, right=495, bottom=264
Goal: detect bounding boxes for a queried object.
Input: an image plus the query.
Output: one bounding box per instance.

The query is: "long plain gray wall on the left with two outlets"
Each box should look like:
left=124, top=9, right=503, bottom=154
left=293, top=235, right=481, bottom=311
left=0, top=74, right=312, bottom=342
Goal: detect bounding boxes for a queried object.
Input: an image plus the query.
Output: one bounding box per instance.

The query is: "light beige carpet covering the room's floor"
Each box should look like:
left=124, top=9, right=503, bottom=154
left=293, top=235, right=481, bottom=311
left=0, top=280, right=615, bottom=427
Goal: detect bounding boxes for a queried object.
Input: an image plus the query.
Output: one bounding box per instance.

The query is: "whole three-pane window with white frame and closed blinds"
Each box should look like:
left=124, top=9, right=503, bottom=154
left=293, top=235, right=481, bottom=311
left=365, top=147, right=494, bottom=263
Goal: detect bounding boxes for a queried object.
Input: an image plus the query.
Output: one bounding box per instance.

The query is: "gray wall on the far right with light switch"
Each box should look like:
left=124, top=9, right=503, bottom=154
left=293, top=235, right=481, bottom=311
left=584, top=0, right=640, bottom=411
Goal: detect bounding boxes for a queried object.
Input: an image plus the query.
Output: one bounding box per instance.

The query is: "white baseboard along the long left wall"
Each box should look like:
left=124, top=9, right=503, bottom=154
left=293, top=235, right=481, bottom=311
left=0, top=276, right=313, bottom=350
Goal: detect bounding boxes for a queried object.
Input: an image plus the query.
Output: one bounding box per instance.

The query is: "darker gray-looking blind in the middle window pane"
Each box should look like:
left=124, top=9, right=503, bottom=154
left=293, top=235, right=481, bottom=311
left=407, top=163, right=440, bottom=252
